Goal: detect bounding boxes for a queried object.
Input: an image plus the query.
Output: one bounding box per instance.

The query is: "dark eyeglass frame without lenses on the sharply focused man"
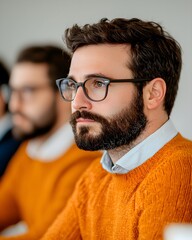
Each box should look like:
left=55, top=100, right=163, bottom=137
left=56, top=76, right=152, bottom=102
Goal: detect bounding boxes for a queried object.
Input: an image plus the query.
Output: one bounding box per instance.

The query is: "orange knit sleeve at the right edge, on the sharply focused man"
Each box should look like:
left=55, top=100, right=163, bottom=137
left=137, top=156, right=192, bottom=240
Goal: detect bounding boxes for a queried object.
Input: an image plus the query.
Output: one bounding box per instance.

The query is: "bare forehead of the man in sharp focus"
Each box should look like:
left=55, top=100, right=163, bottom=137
left=69, top=44, right=131, bottom=78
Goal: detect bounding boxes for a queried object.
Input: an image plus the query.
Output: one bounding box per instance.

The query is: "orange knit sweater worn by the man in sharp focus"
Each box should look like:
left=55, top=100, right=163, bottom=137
left=43, top=134, right=192, bottom=240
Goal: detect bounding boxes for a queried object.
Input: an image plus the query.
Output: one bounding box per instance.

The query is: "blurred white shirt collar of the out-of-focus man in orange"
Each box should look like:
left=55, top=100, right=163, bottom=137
left=27, top=124, right=74, bottom=162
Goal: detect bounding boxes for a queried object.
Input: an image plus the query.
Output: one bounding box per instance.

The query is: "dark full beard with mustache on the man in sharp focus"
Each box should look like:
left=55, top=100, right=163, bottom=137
left=70, top=91, right=147, bottom=151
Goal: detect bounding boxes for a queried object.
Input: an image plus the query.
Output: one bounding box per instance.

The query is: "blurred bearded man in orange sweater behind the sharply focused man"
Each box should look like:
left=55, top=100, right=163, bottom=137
left=0, top=46, right=101, bottom=240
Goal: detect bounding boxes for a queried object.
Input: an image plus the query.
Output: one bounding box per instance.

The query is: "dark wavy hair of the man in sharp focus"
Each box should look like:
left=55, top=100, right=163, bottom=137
left=65, top=18, right=182, bottom=115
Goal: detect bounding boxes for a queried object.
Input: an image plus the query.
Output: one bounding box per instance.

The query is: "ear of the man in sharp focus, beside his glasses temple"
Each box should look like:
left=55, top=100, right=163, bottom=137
left=143, top=78, right=166, bottom=110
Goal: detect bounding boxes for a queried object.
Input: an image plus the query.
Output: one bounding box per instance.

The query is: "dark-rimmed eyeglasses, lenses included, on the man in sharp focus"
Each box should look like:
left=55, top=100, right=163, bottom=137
left=56, top=76, right=152, bottom=102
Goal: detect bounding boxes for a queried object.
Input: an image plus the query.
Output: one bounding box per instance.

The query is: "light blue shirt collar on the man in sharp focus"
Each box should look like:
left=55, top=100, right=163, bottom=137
left=101, top=119, right=178, bottom=174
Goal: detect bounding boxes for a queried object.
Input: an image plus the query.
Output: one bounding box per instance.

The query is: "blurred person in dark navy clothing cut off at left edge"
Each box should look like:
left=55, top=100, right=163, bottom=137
left=0, top=61, right=20, bottom=177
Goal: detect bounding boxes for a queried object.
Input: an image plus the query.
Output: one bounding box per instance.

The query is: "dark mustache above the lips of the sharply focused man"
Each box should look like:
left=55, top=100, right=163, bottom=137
left=70, top=111, right=108, bottom=124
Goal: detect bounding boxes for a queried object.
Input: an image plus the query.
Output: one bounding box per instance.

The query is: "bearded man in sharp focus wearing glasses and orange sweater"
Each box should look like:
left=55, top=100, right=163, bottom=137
left=43, top=19, right=192, bottom=240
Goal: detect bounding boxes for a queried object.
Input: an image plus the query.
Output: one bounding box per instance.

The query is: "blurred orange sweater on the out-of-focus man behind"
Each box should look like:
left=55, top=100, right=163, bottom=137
left=0, top=142, right=101, bottom=240
